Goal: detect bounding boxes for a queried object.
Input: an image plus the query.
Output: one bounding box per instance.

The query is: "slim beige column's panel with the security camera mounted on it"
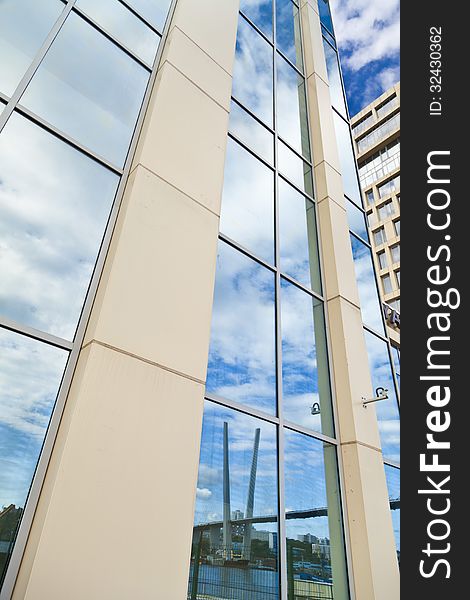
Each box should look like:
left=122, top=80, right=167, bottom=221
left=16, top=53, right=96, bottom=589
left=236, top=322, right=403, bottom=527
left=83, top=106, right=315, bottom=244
left=328, top=296, right=381, bottom=451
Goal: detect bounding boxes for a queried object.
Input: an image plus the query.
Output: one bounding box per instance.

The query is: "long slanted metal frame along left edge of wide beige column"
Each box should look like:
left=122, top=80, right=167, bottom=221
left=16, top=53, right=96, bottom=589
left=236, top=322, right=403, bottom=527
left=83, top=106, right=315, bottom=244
left=0, top=0, right=177, bottom=600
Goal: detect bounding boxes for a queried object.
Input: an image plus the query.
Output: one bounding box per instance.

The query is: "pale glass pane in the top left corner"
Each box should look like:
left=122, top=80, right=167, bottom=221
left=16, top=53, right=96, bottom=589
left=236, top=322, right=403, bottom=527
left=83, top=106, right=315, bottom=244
left=0, top=0, right=64, bottom=96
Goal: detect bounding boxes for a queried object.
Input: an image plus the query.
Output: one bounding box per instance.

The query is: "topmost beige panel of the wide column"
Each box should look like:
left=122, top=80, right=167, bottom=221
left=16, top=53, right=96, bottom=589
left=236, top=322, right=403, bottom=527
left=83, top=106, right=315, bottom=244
left=172, top=0, right=239, bottom=74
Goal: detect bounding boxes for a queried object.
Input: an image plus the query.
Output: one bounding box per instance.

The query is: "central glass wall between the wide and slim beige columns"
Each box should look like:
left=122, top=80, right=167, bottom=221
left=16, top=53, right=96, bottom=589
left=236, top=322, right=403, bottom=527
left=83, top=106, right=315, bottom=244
left=187, top=0, right=349, bottom=600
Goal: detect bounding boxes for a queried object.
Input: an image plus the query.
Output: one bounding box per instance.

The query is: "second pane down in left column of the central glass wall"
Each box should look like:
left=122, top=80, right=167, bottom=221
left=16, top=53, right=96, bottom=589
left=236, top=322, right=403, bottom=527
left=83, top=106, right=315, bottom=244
left=232, top=17, right=274, bottom=127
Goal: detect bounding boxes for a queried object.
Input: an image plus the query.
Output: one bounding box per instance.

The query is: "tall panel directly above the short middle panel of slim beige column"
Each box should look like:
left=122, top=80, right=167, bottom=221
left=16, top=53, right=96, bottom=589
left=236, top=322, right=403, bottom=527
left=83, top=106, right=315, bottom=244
left=307, top=74, right=341, bottom=173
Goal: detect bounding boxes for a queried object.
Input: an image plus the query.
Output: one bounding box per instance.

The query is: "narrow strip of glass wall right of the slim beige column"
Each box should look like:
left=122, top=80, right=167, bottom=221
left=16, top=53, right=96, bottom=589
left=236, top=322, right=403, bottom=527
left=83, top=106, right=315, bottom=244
left=318, top=0, right=400, bottom=556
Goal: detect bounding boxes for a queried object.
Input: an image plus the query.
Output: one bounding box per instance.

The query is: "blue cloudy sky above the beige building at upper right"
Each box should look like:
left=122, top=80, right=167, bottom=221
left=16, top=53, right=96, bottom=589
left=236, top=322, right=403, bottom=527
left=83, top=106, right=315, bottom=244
left=331, top=0, right=400, bottom=116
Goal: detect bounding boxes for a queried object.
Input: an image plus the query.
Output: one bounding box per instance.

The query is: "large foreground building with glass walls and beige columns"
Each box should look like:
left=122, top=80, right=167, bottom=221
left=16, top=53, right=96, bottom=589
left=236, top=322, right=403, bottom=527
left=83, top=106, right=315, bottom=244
left=0, top=0, right=398, bottom=600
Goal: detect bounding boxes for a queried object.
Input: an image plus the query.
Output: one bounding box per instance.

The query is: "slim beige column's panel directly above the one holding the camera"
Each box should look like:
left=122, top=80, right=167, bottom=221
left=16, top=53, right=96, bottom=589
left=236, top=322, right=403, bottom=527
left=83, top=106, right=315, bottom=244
left=318, top=199, right=360, bottom=306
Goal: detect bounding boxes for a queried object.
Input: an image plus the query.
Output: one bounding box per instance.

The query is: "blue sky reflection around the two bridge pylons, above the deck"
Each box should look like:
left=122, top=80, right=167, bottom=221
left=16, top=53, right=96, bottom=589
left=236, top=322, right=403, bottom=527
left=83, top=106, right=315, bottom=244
left=195, top=401, right=278, bottom=530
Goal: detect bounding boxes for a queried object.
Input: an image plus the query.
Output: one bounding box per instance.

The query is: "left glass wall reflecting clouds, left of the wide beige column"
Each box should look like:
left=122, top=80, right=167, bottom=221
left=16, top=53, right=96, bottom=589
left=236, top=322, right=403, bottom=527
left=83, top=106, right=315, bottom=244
left=0, top=0, right=171, bottom=586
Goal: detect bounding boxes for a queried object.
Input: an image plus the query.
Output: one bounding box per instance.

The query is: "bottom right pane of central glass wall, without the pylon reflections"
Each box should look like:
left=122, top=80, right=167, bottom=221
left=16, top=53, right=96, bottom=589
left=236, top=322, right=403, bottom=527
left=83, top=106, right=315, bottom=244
left=284, top=430, right=349, bottom=600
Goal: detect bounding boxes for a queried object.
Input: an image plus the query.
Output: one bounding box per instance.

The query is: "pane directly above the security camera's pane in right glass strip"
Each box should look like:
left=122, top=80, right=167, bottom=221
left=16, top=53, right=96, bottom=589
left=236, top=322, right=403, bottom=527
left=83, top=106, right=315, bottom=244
left=350, top=235, right=384, bottom=333
